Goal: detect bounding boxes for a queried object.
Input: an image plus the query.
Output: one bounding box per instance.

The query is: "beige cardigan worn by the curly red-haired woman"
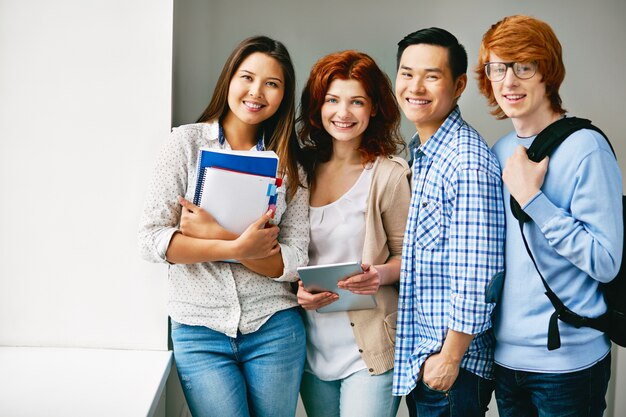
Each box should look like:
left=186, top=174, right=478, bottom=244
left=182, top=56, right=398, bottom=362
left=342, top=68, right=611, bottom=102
left=348, top=156, right=411, bottom=375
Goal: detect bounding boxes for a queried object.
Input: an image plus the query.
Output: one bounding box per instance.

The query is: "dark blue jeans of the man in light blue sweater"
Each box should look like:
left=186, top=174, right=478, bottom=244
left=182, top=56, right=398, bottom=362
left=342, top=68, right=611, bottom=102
left=496, top=353, right=611, bottom=417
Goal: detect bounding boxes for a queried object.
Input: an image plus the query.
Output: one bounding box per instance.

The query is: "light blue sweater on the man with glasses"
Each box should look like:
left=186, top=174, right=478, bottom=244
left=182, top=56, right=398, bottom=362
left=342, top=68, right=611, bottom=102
left=493, top=125, right=623, bottom=373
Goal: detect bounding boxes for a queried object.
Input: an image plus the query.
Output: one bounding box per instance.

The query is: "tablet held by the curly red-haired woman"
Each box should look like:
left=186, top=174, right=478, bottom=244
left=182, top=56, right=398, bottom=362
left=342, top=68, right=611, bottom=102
left=298, top=262, right=376, bottom=313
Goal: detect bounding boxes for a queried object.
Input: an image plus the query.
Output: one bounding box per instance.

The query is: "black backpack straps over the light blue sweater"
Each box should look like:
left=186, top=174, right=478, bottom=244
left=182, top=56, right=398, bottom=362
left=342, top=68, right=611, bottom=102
left=511, top=117, right=615, bottom=350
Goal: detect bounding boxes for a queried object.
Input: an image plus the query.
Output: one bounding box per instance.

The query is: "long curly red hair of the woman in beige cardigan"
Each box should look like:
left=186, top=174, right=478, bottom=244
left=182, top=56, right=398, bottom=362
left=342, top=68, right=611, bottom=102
left=298, top=50, right=404, bottom=180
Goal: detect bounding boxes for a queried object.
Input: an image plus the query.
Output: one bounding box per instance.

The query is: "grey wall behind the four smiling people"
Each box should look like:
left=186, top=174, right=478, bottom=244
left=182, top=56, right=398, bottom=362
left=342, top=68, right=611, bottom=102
left=174, top=0, right=626, bottom=417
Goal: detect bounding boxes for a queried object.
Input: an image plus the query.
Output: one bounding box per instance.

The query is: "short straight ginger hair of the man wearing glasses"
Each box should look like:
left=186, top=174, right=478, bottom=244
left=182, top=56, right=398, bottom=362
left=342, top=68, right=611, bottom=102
left=475, top=15, right=565, bottom=119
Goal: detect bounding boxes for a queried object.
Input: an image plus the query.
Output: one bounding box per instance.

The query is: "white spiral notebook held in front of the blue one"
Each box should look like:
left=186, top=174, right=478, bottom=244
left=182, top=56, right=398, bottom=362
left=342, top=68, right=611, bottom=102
left=198, top=167, right=280, bottom=234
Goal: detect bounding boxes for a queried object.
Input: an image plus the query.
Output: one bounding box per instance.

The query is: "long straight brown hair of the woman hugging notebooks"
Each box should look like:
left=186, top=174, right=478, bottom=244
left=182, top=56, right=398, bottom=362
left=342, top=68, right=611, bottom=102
left=198, top=36, right=302, bottom=199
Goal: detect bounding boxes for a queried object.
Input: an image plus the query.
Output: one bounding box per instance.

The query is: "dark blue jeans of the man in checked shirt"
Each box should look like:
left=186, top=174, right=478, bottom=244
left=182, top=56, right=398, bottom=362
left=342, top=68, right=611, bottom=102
left=406, top=368, right=492, bottom=417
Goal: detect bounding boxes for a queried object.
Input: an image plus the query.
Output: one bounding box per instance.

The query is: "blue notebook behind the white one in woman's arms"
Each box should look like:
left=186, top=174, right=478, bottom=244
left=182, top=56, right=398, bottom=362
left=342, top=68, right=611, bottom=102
left=193, top=148, right=278, bottom=205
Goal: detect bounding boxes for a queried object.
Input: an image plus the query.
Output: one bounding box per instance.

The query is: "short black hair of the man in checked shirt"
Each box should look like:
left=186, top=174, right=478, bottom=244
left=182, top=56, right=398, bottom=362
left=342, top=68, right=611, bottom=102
left=396, top=27, right=467, bottom=80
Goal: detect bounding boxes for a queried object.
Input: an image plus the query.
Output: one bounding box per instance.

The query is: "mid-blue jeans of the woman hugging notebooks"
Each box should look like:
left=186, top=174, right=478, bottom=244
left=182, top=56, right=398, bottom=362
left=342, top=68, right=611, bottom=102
left=172, top=308, right=306, bottom=417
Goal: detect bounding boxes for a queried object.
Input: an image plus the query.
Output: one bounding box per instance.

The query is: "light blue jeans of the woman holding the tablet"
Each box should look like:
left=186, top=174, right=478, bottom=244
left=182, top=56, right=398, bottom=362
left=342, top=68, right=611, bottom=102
left=300, top=369, right=400, bottom=417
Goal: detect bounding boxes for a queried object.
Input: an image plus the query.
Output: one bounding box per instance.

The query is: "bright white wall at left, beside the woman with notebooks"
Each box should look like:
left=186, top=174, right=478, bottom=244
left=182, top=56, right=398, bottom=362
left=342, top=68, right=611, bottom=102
left=0, top=0, right=173, bottom=350
